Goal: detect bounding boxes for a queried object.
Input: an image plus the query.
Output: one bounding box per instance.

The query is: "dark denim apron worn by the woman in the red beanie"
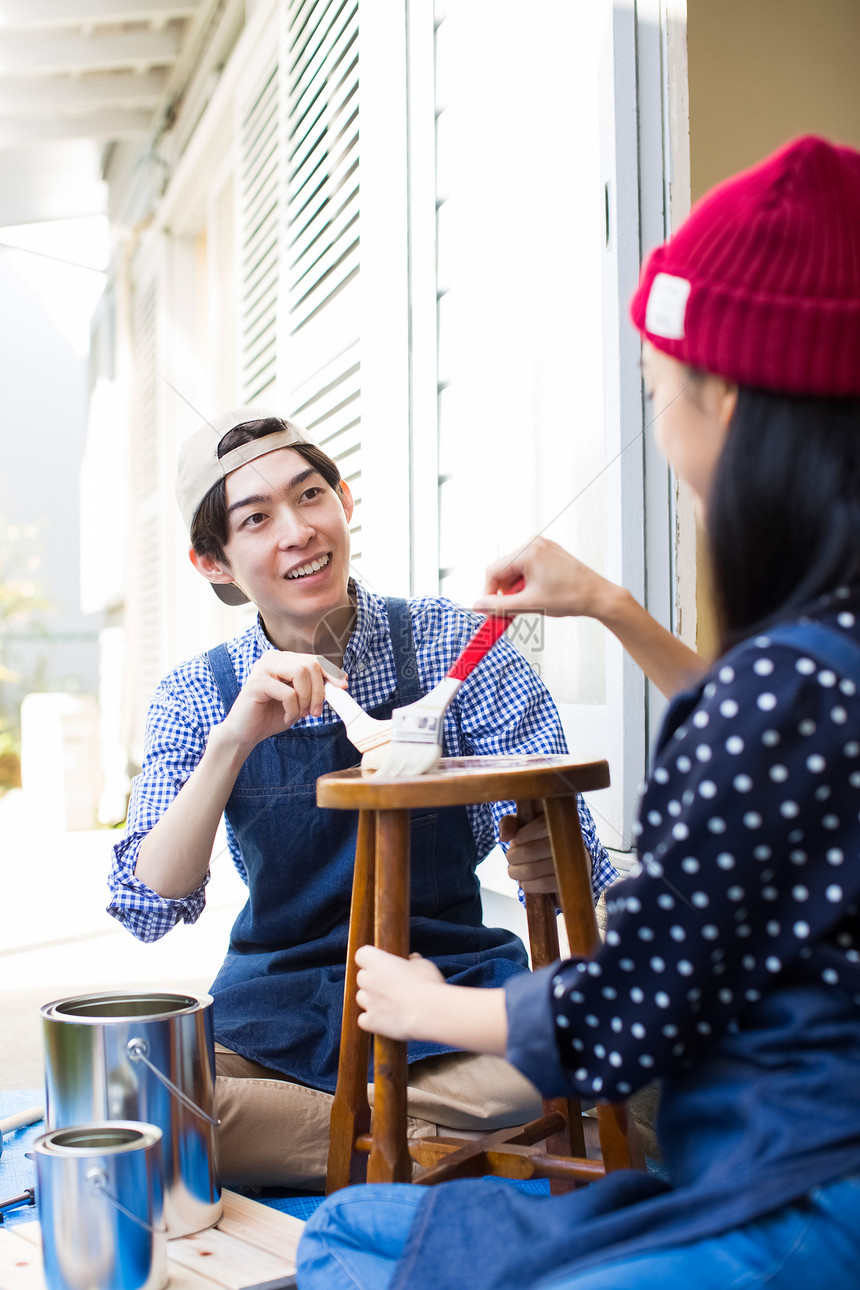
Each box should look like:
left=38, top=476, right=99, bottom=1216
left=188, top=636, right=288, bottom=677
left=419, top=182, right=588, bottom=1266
left=391, top=623, right=860, bottom=1290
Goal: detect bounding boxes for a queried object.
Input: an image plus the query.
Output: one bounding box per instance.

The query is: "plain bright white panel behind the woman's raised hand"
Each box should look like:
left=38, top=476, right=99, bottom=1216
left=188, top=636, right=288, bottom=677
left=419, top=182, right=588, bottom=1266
left=436, top=0, right=605, bottom=703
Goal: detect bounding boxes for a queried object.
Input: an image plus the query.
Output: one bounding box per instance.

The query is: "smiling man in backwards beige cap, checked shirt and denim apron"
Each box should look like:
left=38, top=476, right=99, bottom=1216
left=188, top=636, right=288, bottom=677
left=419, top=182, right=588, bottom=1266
left=110, top=408, right=615, bottom=1187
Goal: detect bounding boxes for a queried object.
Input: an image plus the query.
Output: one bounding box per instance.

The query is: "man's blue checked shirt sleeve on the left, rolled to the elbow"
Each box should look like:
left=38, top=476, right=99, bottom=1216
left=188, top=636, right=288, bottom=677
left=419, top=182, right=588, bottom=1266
left=107, top=673, right=223, bottom=940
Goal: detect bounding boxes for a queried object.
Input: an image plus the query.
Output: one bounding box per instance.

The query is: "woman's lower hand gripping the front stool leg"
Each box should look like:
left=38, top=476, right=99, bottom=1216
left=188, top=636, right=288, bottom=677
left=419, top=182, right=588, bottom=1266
left=356, top=946, right=443, bottom=1040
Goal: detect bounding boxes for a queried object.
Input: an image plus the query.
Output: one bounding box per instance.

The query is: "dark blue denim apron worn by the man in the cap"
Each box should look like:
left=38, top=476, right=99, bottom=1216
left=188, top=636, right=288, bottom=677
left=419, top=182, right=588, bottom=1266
left=208, top=600, right=527, bottom=1090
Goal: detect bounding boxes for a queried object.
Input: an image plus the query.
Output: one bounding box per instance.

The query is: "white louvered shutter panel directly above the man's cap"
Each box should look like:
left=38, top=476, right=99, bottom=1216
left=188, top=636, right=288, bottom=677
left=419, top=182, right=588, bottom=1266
left=279, top=0, right=362, bottom=570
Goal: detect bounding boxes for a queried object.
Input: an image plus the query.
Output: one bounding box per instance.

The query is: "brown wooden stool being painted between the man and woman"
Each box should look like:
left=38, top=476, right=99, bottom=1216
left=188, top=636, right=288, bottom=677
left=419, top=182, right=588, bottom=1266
left=317, top=755, right=645, bottom=1192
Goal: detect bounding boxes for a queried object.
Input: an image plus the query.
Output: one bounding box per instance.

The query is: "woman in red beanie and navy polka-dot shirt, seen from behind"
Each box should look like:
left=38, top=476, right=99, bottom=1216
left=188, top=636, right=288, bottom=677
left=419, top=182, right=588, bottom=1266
left=299, top=138, right=860, bottom=1290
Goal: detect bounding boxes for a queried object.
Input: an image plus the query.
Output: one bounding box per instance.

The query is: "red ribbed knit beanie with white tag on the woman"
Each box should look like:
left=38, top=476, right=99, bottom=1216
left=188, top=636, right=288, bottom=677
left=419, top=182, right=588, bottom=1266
left=630, top=135, right=860, bottom=397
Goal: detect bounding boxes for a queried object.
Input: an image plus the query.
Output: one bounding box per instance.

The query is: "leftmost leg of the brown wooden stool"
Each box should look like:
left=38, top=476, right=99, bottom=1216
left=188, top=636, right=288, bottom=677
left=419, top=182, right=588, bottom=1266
left=325, top=810, right=376, bottom=1192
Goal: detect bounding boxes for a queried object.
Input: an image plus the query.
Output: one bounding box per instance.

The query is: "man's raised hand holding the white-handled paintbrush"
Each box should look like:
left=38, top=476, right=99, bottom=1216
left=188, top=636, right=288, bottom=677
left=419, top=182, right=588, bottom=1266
left=220, top=649, right=347, bottom=752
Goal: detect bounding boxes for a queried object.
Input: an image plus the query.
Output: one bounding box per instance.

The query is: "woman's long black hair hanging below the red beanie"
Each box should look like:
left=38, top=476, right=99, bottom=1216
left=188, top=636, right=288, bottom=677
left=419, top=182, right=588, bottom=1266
left=708, top=386, right=860, bottom=650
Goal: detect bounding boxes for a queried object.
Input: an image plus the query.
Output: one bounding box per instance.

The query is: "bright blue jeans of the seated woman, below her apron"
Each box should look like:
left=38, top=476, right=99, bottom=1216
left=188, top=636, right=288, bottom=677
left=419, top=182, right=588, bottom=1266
left=298, top=1175, right=860, bottom=1290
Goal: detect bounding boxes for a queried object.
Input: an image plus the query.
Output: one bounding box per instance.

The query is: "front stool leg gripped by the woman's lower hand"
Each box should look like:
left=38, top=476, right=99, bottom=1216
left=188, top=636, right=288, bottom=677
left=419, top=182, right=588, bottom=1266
left=367, top=810, right=413, bottom=1183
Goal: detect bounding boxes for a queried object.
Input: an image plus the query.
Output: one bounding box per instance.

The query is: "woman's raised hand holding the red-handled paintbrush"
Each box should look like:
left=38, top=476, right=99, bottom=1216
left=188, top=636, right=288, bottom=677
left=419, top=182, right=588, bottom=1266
left=474, top=538, right=620, bottom=619
